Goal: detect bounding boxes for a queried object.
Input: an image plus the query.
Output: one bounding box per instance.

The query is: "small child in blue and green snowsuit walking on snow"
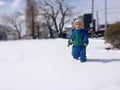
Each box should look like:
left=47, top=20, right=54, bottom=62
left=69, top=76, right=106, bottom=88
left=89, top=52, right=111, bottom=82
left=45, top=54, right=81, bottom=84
left=68, top=19, right=89, bottom=62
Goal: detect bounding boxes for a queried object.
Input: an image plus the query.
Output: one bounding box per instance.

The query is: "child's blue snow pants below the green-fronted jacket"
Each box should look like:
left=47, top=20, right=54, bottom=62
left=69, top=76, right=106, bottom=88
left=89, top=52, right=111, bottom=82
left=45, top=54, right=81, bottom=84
left=72, top=46, right=86, bottom=62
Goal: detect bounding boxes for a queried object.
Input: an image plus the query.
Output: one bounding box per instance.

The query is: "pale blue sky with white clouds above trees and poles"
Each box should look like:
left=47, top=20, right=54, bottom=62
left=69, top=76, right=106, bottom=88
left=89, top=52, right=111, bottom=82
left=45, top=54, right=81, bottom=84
left=0, top=0, right=120, bottom=23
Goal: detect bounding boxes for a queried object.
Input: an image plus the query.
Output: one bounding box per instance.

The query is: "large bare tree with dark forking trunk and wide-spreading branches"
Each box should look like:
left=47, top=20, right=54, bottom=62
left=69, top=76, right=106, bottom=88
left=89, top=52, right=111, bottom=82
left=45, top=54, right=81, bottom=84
left=39, top=0, right=73, bottom=37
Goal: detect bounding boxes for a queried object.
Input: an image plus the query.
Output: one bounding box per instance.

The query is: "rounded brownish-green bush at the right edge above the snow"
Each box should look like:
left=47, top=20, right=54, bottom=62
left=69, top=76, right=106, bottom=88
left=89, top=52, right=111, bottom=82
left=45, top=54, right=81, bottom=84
left=104, top=22, right=120, bottom=49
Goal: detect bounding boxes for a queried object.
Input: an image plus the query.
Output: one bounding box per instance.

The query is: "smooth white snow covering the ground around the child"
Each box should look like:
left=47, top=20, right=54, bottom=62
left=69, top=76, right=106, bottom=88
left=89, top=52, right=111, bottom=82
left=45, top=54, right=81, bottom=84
left=0, top=39, right=120, bottom=90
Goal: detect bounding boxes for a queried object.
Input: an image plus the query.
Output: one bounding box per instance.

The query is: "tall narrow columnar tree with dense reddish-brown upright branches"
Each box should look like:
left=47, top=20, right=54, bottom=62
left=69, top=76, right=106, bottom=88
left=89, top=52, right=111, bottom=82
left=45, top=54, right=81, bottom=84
left=26, top=0, right=38, bottom=39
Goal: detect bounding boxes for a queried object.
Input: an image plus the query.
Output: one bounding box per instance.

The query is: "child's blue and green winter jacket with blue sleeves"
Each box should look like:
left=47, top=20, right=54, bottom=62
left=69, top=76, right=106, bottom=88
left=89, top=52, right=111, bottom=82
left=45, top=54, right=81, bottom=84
left=68, top=29, right=89, bottom=46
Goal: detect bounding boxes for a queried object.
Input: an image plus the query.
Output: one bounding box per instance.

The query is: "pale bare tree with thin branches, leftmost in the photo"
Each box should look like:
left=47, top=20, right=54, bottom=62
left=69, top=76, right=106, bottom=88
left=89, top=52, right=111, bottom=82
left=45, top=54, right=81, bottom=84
left=2, top=12, right=24, bottom=39
